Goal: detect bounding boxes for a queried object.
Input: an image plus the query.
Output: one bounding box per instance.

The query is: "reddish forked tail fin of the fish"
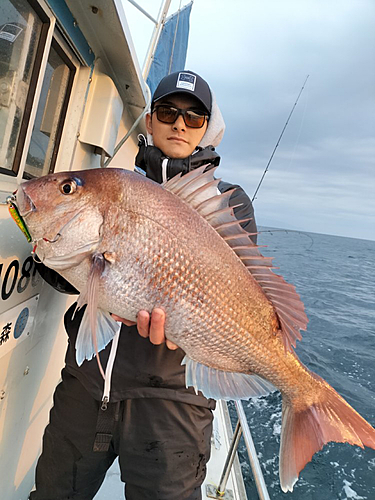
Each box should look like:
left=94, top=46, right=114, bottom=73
left=279, top=373, right=375, bottom=493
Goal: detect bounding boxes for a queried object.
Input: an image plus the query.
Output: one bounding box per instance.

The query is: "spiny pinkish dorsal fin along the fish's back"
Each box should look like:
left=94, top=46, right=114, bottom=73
left=163, top=165, right=308, bottom=351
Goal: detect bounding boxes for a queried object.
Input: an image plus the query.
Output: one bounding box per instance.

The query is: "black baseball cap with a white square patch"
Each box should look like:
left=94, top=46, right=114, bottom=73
left=151, top=70, right=212, bottom=114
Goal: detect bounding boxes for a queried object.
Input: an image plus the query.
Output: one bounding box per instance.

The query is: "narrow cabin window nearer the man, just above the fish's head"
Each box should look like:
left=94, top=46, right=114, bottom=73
left=24, top=40, right=74, bottom=179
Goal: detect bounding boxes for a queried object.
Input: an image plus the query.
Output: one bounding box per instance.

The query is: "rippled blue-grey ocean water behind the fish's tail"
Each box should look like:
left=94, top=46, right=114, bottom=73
left=230, top=228, right=375, bottom=500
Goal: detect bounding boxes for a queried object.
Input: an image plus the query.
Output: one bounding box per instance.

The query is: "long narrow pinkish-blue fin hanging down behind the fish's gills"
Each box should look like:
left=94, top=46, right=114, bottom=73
left=76, top=253, right=118, bottom=378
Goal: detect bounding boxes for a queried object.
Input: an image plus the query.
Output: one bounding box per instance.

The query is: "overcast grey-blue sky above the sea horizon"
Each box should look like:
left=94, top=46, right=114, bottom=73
left=124, top=0, right=375, bottom=240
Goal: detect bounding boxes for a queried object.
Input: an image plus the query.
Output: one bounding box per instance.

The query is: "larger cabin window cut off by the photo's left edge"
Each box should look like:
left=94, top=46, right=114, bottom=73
left=0, top=0, right=44, bottom=175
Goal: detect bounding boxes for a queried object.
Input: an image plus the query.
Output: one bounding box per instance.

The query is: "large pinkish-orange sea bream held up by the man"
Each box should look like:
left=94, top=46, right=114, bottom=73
left=8, top=167, right=375, bottom=492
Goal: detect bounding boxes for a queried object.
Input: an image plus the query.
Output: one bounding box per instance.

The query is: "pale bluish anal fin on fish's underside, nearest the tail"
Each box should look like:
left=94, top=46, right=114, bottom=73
left=181, top=356, right=276, bottom=401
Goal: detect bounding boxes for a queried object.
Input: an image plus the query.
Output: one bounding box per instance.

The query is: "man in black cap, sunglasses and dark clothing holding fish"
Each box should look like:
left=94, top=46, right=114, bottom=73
left=30, top=71, right=256, bottom=500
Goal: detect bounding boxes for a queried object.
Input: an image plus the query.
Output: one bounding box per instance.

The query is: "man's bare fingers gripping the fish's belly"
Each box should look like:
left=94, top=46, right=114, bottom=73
left=112, top=307, right=178, bottom=351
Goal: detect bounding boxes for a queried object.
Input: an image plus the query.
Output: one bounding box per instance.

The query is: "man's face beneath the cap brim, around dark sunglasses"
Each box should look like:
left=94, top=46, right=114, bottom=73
left=146, top=94, right=207, bottom=158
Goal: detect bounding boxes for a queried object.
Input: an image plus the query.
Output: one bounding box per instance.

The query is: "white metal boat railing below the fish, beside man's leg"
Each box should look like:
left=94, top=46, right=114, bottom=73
left=206, top=401, right=270, bottom=500
